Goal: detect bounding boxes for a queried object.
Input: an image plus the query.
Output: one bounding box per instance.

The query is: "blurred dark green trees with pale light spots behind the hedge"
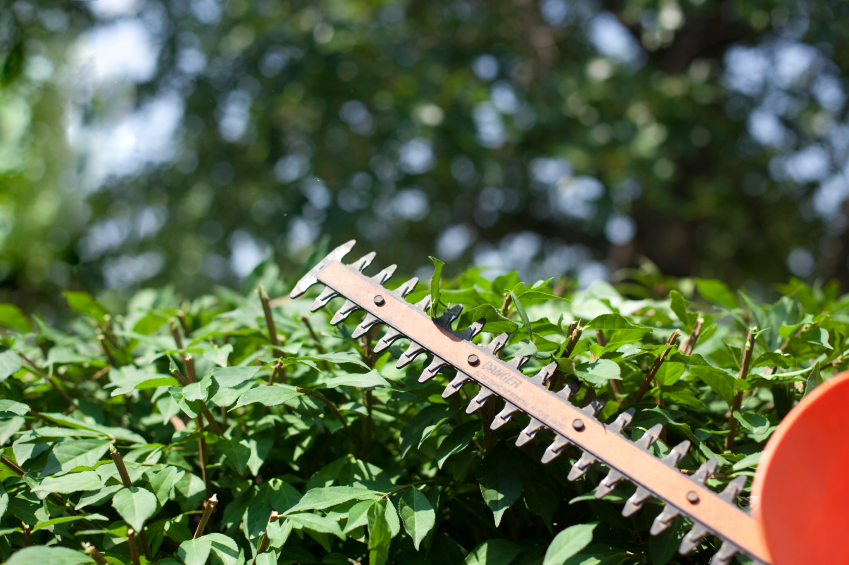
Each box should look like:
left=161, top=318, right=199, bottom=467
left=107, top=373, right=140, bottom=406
left=0, top=0, right=849, bottom=305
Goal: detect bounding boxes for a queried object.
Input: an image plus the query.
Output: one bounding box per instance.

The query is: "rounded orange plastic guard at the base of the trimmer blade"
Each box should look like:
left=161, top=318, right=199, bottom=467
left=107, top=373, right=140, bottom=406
left=752, top=371, right=849, bottom=565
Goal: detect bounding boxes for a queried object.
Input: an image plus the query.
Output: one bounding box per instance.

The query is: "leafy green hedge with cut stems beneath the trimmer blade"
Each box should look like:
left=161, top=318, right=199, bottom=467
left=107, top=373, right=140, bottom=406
left=0, top=258, right=849, bottom=565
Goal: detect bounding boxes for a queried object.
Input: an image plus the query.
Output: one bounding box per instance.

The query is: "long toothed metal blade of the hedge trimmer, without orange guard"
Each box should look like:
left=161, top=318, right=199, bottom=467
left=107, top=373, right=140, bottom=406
left=293, top=244, right=771, bottom=565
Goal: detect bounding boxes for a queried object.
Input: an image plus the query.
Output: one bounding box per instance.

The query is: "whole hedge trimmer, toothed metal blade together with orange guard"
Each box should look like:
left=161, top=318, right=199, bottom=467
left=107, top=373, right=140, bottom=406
left=291, top=241, right=849, bottom=565
